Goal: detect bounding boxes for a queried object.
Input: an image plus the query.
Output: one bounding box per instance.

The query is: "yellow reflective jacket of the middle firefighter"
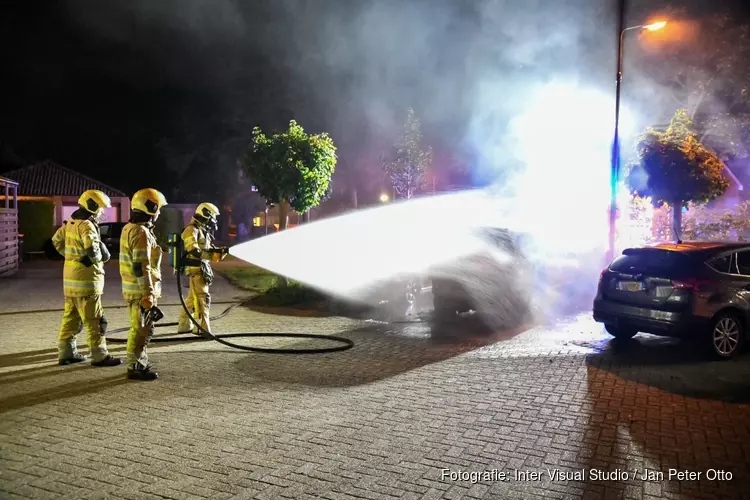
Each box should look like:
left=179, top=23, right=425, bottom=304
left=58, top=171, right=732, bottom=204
left=120, top=222, right=162, bottom=300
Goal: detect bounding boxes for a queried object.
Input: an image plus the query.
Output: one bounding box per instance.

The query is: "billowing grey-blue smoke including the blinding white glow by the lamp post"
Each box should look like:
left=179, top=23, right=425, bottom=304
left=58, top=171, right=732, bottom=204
left=68, top=0, right=680, bottom=320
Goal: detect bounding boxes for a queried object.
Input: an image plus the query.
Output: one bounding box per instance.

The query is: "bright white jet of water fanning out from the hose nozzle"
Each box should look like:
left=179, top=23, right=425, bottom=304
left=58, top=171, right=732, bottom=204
left=230, top=190, right=510, bottom=299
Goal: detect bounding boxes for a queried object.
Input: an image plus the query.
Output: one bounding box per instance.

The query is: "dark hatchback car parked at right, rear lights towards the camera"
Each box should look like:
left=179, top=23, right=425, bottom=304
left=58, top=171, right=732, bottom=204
left=594, top=242, right=750, bottom=358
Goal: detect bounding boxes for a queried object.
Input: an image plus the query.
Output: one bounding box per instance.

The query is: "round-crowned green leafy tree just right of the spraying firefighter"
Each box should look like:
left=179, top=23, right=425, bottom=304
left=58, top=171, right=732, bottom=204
left=240, top=120, right=337, bottom=230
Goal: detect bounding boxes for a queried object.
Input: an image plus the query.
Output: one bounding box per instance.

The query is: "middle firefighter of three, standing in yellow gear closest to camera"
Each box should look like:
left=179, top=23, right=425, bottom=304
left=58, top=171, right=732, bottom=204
left=120, top=188, right=167, bottom=380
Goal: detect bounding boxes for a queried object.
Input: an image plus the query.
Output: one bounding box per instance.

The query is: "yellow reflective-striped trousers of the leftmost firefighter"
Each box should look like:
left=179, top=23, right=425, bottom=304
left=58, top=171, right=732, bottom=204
left=57, top=294, right=109, bottom=361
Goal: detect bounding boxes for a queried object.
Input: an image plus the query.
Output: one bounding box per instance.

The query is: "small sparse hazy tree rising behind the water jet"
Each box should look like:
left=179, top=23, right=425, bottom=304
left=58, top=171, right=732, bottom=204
left=381, top=108, right=432, bottom=199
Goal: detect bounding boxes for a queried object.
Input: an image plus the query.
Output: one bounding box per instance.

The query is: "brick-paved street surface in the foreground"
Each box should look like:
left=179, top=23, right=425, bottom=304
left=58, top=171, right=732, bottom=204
left=0, top=260, right=750, bottom=500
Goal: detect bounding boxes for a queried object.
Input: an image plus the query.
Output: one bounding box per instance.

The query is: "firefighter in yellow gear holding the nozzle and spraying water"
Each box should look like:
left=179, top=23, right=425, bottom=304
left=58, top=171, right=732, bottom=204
left=177, top=203, right=227, bottom=334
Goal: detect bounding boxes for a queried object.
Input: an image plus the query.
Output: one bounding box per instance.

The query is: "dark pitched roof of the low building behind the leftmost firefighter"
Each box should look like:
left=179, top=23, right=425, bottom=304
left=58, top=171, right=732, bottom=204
left=3, top=160, right=127, bottom=197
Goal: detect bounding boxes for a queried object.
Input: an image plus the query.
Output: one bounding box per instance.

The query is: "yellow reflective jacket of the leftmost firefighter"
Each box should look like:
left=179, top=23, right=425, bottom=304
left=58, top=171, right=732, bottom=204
left=52, top=219, right=104, bottom=297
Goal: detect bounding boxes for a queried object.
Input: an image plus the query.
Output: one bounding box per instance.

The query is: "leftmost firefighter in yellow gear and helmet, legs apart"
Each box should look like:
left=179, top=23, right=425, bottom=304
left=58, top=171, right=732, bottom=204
left=52, top=189, right=121, bottom=366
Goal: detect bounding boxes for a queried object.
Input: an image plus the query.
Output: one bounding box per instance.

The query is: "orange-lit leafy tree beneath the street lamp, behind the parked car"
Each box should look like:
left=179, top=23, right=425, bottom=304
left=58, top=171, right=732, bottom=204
left=626, top=109, right=729, bottom=238
